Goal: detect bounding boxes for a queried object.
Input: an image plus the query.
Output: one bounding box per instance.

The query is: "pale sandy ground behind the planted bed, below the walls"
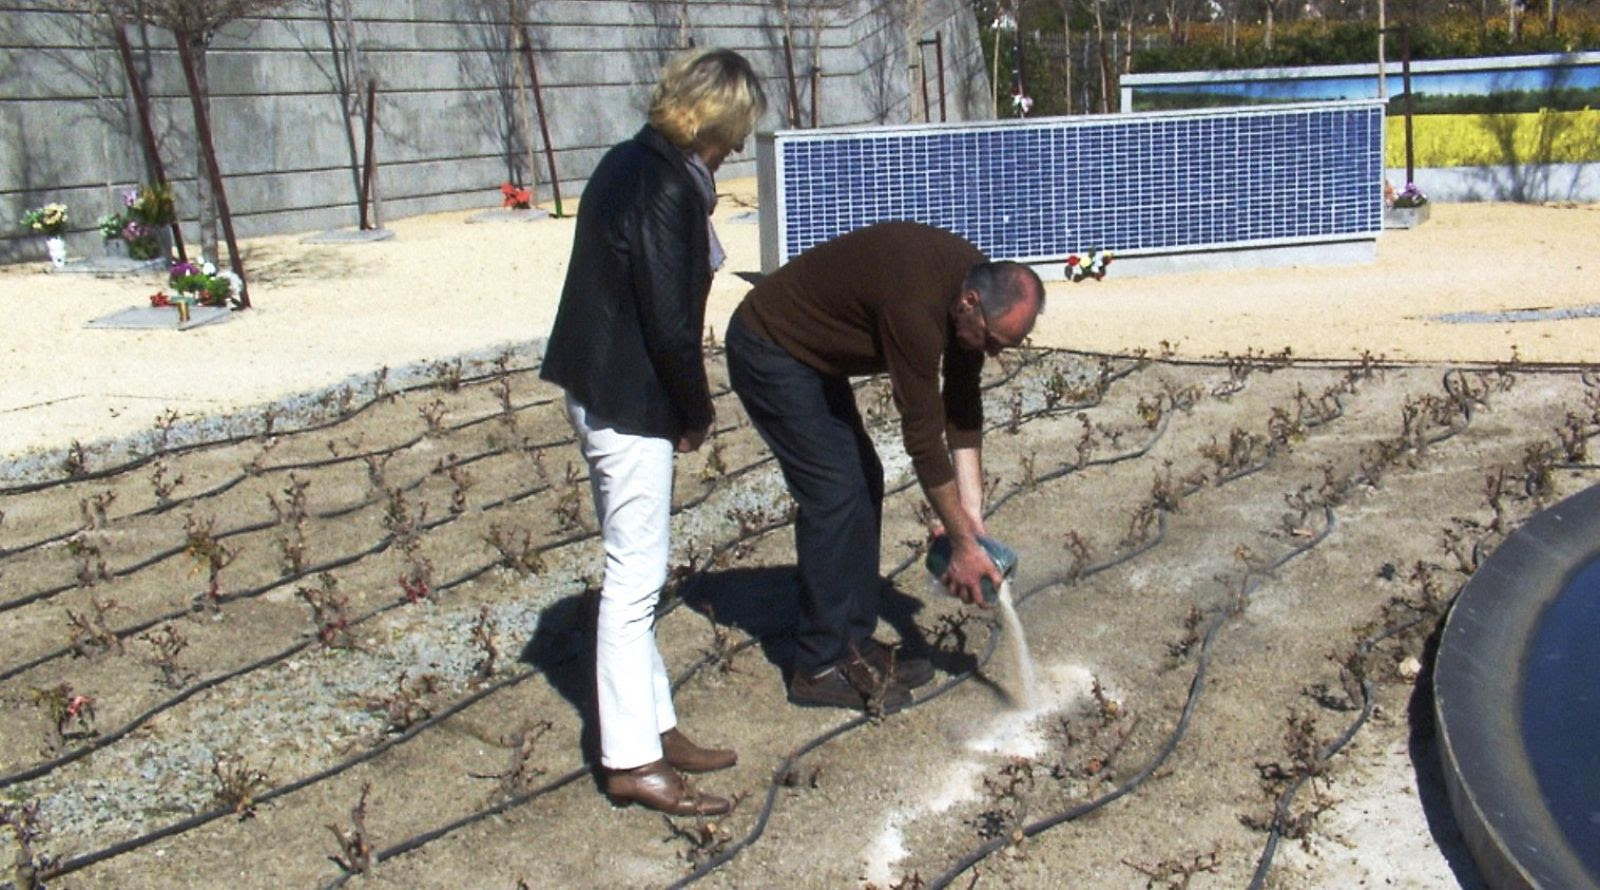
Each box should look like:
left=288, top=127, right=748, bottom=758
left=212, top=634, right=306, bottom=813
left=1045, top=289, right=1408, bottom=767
left=0, top=179, right=1600, bottom=455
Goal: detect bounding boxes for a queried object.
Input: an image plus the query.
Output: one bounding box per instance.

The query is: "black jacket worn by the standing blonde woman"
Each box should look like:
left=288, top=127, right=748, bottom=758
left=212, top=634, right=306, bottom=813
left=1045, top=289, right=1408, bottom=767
left=539, top=126, right=712, bottom=440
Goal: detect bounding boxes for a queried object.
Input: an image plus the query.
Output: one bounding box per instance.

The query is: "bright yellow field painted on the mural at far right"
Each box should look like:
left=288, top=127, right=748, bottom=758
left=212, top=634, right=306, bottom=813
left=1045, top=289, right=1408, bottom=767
left=1384, top=109, right=1600, bottom=166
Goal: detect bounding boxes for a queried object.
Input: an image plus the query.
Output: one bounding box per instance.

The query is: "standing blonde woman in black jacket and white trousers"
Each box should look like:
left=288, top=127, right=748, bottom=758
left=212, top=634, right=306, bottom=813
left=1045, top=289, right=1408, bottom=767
left=541, top=50, right=766, bottom=815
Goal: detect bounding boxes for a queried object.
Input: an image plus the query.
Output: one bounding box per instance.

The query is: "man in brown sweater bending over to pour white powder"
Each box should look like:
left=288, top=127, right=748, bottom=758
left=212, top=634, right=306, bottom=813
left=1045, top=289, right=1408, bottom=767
left=726, top=223, right=1045, bottom=712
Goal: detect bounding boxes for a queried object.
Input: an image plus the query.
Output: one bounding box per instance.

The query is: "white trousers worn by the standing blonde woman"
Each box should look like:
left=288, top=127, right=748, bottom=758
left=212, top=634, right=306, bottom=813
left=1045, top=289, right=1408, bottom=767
left=566, top=397, right=678, bottom=770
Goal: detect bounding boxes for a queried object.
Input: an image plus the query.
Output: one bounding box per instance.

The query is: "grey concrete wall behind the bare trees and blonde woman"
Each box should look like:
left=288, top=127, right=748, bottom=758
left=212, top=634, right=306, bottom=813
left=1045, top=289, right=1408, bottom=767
left=0, top=0, right=992, bottom=261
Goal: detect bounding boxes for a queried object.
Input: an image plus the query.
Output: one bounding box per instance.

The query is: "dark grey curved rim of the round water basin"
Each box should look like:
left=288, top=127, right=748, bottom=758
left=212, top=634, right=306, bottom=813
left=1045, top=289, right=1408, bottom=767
left=1434, top=485, right=1600, bottom=890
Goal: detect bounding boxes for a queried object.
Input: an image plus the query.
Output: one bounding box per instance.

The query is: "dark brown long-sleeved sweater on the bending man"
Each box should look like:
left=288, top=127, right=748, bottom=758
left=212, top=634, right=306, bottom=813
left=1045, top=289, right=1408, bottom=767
left=738, top=223, right=984, bottom=487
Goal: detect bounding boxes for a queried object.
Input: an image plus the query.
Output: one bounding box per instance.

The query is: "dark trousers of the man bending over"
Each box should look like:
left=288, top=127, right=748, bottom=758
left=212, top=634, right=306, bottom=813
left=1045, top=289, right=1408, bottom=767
left=725, top=315, right=883, bottom=671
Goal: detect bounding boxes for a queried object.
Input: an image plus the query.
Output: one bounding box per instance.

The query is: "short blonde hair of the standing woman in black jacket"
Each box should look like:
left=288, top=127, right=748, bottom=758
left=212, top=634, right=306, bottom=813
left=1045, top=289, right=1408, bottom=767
left=650, top=50, right=766, bottom=149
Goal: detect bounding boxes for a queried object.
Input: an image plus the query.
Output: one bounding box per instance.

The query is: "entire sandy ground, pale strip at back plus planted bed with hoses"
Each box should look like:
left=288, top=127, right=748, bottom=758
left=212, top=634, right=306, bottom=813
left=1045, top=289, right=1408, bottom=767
left=0, top=182, right=1600, bottom=887
